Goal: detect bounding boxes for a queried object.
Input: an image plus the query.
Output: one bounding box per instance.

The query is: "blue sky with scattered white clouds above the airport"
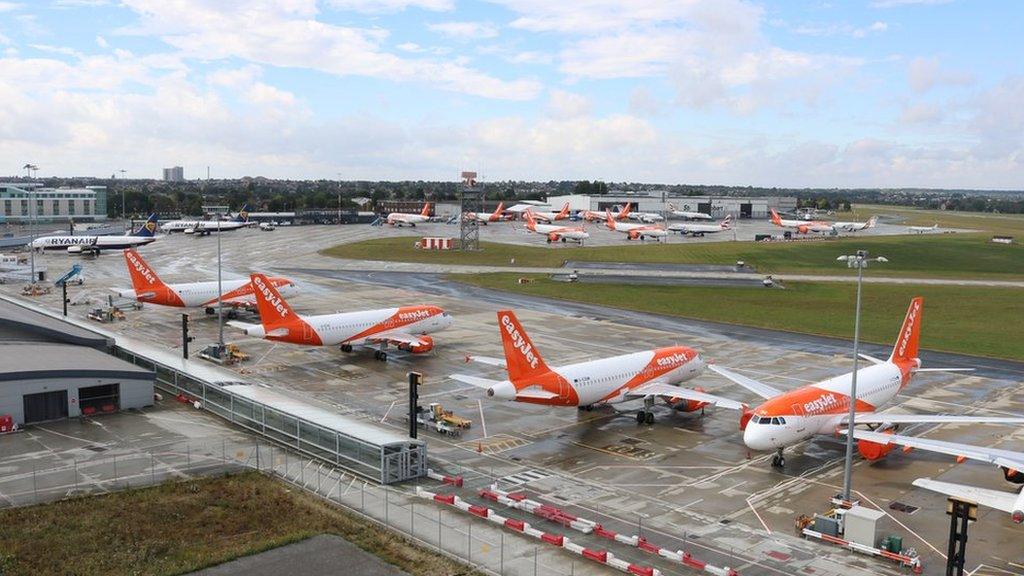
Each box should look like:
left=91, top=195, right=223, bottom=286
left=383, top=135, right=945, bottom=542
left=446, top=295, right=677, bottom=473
left=0, top=0, right=1024, bottom=190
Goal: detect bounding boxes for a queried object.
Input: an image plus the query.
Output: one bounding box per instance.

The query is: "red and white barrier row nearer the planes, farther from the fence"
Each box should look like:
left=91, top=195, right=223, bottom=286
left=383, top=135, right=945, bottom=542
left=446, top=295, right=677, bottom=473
left=479, top=484, right=739, bottom=576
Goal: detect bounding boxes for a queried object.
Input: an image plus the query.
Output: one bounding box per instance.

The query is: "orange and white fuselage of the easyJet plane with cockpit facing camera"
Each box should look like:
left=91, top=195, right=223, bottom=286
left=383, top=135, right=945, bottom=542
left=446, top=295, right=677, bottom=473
left=743, top=362, right=903, bottom=450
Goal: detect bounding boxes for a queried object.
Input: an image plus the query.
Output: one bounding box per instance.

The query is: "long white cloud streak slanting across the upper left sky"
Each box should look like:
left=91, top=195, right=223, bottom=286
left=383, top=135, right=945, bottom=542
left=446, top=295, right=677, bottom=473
left=117, top=0, right=541, bottom=99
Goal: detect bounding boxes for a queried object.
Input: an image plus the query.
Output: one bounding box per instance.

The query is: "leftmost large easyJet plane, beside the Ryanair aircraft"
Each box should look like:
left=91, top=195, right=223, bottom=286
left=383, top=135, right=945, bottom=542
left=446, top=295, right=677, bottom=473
left=114, top=243, right=298, bottom=316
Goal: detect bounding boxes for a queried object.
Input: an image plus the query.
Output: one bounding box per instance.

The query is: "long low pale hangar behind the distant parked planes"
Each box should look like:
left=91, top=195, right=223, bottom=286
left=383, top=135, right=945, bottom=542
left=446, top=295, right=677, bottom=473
left=545, top=191, right=797, bottom=218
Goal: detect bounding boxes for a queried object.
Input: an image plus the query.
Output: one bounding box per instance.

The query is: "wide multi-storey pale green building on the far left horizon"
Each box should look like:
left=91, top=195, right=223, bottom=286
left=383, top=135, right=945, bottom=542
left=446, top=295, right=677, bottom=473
left=0, top=182, right=106, bottom=223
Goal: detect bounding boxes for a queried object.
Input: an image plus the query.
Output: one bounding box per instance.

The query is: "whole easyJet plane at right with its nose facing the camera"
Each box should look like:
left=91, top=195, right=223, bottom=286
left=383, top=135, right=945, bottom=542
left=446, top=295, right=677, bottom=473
left=710, top=297, right=1024, bottom=469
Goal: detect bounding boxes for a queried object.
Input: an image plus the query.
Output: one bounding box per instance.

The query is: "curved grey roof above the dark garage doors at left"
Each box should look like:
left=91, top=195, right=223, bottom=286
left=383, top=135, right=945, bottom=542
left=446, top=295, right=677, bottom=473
left=0, top=342, right=154, bottom=381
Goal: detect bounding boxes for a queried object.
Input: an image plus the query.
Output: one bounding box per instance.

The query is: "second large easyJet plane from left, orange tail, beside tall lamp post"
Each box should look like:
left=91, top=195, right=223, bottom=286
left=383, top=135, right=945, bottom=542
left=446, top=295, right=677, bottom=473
left=234, top=274, right=452, bottom=362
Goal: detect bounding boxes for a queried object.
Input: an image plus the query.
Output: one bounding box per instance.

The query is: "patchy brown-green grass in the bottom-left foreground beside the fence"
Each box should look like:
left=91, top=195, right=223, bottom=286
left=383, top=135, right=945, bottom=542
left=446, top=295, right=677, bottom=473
left=0, top=472, right=469, bottom=576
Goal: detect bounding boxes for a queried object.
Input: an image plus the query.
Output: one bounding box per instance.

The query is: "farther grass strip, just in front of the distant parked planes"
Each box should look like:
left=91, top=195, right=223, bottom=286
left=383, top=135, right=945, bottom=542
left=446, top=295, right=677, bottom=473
left=322, top=234, right=1024, bottom=279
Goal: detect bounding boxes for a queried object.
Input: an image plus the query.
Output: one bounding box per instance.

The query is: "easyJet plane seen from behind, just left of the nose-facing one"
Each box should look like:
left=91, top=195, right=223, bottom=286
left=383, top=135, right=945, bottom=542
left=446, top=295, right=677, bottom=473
left=451, top=310, right=744, bottom=424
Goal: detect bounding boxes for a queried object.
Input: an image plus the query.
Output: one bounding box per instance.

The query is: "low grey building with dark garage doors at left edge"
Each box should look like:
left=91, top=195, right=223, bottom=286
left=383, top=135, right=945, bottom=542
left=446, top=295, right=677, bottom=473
left=0, top=299, right=155, bottom=425
